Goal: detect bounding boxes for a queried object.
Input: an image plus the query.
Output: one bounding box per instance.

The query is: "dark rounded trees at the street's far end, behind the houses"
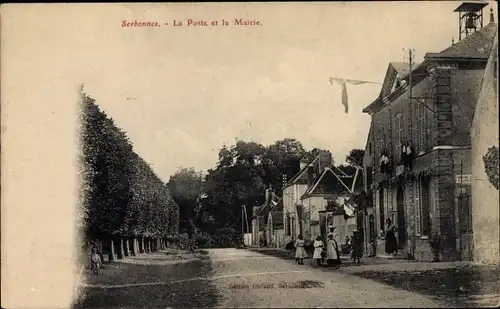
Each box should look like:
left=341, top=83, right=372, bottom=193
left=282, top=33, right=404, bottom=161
left=168, top=138, right=364, bottom=247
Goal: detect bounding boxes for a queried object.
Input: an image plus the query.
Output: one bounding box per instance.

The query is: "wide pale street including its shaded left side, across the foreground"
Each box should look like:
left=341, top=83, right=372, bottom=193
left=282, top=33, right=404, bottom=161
left=76, top=249, right=500, bottom=308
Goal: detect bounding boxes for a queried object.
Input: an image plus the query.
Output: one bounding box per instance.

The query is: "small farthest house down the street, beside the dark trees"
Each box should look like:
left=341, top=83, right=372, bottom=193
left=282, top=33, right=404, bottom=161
left=251, top=186, right=285, bottom=248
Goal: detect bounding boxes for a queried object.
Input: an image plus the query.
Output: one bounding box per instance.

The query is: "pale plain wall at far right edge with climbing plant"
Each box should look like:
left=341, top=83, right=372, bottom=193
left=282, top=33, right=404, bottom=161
left=471, top=33, right=500, bottom=263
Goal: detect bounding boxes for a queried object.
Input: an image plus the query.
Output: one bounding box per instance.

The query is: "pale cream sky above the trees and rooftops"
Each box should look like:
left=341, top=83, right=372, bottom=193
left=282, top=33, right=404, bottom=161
left=72, top=1, right=496, bottom=181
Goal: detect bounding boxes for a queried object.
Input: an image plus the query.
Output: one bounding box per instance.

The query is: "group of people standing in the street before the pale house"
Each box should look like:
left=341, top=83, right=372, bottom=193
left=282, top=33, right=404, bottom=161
left=295, top=227, right=363, bottom=266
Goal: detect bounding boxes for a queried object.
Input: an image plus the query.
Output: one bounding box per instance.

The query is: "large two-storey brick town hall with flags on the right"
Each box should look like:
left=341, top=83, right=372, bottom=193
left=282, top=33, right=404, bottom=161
left=363, top=4, right=497, bottom=260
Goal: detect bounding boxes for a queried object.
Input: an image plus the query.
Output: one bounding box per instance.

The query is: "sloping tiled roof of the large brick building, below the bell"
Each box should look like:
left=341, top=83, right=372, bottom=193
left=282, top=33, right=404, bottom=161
left=427, top=23, right=498, bottom=58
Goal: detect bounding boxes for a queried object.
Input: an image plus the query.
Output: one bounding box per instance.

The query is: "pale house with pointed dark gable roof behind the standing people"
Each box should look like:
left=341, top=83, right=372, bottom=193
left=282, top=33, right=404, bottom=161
left=283, top=151, right=361, bottom=244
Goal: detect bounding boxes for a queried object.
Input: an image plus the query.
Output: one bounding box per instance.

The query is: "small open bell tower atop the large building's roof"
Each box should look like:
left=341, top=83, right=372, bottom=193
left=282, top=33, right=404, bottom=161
left=454, top=2, right=488, bottom=41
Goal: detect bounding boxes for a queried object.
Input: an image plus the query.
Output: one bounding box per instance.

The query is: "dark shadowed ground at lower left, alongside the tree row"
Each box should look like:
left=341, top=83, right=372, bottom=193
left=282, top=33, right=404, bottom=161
left=73, top=260, right=218, bottom=309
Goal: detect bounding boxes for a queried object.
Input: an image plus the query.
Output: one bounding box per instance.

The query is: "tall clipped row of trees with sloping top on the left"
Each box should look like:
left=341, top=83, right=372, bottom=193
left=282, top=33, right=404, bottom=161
left=80, top=93, right=179, bottom=258
